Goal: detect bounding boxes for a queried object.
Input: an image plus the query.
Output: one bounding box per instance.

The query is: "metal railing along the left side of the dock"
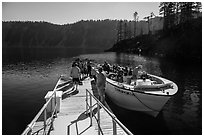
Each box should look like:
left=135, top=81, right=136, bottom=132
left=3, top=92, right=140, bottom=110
left=22, top=76, right=61, bottom=135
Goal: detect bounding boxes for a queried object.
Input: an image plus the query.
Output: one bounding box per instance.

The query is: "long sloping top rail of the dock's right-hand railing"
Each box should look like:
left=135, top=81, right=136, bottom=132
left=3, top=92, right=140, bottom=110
left=86, top=89, right=133, bottom=135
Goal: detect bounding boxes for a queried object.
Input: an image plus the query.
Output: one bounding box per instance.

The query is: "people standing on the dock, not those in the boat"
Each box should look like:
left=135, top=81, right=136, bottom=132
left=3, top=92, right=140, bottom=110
left=70, top=59, right=106, bottom=103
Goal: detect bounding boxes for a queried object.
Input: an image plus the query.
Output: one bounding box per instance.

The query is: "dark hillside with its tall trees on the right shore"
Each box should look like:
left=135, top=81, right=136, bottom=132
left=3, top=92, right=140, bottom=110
left=107, top=2, right=202, bottom=62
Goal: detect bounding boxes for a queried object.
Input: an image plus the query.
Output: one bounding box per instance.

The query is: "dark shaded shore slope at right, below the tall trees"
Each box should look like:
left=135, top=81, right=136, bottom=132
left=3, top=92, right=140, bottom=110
left=107, top=18, right=202, bottom=62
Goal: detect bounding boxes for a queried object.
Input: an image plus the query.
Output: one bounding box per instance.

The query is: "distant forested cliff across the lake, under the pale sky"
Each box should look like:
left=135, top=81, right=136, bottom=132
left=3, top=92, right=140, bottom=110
left=2, top=18, right=163, bottom=51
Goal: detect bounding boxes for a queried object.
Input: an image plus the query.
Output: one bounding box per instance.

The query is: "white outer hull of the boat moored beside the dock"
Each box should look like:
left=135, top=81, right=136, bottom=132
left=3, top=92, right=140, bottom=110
left=106, top=74, right=178, bottom=117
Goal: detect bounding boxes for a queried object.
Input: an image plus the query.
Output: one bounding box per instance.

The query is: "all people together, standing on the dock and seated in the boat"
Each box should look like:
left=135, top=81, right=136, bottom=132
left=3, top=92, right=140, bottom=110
left=70, top=59, right=146, bottom=102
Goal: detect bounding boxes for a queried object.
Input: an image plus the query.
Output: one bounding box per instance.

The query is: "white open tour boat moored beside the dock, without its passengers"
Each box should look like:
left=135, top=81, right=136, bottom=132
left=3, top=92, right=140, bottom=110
left=105, top=73, right=178, bottom=117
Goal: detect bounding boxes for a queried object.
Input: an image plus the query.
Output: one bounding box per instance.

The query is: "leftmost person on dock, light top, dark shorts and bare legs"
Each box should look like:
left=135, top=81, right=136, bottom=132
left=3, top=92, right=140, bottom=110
left=70, top=62, right=81, bottom=90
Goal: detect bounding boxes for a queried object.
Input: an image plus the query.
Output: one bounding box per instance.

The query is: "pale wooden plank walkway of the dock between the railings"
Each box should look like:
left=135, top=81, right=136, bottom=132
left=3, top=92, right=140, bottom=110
left=47, top=79, right=126, bottom=135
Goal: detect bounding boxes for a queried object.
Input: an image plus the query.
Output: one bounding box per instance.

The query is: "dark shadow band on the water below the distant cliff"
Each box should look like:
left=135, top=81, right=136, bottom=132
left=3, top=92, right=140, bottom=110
left=2, top=47, right=98, bottom=64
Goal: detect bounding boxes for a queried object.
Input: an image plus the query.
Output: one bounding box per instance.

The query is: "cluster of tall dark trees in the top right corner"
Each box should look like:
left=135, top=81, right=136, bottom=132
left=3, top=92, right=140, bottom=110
left=159, top=2, right=202, bottom=31
